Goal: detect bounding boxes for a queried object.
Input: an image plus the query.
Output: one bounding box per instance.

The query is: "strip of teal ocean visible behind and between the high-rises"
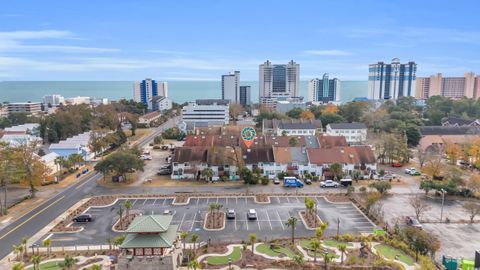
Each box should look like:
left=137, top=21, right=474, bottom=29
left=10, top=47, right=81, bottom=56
left=0, top=81, right=368, bottom=103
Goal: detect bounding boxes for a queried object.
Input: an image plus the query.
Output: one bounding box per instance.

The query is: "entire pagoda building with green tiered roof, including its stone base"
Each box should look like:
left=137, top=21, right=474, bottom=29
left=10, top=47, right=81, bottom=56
left=118, top=215, right=182, bottom=270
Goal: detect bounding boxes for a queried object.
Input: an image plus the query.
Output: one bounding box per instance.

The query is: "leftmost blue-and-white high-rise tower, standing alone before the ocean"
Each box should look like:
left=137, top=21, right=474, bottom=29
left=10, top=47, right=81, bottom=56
left=133, top=78, right=168, bottom=110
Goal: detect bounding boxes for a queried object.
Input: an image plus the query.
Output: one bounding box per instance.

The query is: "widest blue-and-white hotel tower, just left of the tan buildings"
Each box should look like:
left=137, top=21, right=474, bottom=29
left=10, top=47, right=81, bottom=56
left=368, top=58, right=417, bottom=100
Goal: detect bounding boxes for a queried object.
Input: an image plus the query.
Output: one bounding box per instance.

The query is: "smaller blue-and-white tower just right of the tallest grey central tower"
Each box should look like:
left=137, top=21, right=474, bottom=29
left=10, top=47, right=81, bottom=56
left=308, top=73, right=340, bottom=103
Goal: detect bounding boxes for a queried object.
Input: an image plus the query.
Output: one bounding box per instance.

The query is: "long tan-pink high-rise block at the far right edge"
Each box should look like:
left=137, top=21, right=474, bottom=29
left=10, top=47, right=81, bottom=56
left=415, top=72, right=480, bottom=99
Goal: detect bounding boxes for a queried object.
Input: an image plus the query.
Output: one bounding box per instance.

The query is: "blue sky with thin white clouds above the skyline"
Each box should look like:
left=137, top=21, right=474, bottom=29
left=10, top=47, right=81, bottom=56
left=0, top=0, right=480, bottom=80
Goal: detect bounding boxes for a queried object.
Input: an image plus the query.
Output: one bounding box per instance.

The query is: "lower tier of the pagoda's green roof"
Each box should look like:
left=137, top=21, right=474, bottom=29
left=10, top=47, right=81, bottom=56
left=120, top=225, right=178, bottom=248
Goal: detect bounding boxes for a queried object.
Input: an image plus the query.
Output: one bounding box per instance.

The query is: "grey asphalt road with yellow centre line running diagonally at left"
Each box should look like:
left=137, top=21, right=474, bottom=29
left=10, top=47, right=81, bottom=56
left=0, top=118, right=176, bottom=259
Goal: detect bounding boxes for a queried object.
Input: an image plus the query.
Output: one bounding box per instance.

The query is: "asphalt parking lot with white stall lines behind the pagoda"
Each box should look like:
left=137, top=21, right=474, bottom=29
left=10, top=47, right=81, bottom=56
left=40, top=196, right=373, bottom=246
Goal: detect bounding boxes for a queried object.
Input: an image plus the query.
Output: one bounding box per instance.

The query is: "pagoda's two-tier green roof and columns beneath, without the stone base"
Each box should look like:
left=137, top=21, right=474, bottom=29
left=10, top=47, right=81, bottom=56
left=120, top=215, right=178, bottom=257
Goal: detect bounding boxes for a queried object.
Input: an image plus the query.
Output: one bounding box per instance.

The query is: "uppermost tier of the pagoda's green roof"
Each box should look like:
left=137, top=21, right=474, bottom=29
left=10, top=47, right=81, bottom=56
left=126, top=215, right=173, bottom=233
